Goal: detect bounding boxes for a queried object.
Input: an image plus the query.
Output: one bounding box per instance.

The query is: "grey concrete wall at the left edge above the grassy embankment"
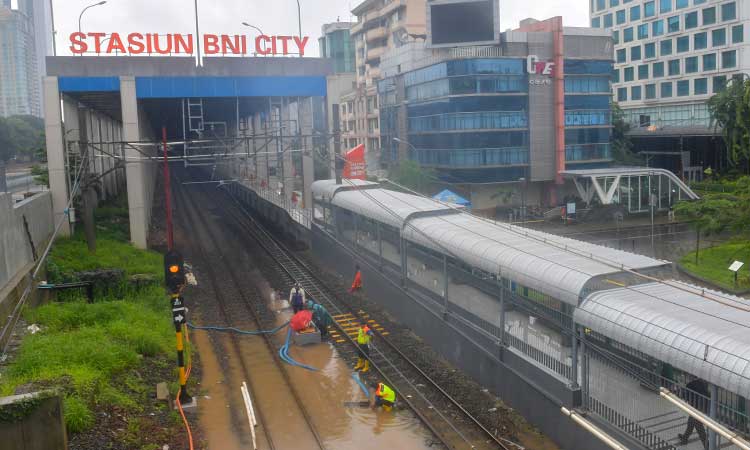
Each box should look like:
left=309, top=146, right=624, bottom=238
left=0, top=192, right=54, bottom=292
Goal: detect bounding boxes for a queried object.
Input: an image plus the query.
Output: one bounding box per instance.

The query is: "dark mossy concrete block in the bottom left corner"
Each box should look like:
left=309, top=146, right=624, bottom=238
left=0, top=393, right=68, bottom=450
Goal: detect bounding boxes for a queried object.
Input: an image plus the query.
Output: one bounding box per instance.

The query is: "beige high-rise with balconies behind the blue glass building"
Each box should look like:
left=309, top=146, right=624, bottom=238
left=340, top=0, right=426, bottom=172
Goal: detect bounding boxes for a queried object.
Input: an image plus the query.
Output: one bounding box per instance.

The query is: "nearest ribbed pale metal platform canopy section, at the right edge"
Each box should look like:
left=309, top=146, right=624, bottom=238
left=575, top=281, right=750, bottom=397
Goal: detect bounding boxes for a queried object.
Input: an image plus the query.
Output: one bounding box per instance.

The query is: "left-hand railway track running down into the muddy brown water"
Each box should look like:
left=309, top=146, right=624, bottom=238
left=174, top=175, right=326, bottom=450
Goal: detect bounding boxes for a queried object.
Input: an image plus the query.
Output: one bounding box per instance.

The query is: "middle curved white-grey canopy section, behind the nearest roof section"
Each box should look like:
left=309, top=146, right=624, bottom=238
left=404, top=214, right=665, bottom=306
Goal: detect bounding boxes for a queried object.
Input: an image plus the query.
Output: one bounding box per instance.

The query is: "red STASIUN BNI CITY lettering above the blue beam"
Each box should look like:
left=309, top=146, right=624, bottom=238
left=69, top=32, right=310, bottom=56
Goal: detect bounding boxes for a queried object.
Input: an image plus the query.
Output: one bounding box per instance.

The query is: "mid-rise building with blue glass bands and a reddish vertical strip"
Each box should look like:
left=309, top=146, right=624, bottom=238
left=378, top=18, right=613, bottom=209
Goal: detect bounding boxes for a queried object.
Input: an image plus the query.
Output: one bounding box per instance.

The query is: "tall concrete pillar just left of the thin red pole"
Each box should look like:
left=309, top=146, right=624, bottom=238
left=120, top=76, right=148, bottom=248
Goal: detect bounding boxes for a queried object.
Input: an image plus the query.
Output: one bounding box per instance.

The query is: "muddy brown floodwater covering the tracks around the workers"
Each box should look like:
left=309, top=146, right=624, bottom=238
left=192, top=271, right=440, bottom=450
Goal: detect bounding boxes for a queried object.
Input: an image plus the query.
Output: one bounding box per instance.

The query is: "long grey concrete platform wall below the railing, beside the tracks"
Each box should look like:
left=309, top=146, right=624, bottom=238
left=312, top=227, right=607, bottom=450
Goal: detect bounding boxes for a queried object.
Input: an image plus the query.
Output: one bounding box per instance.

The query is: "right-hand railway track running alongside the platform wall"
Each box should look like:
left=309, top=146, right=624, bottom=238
left=212, top=182, right=523, bottom=450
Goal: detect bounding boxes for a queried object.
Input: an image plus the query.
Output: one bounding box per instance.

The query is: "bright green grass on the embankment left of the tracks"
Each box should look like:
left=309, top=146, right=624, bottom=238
left=0, top=200, right=174, bottom=433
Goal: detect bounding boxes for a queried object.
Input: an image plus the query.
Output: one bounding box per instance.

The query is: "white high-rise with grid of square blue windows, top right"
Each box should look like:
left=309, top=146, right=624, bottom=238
left=590, top=0, right=750, bottom=177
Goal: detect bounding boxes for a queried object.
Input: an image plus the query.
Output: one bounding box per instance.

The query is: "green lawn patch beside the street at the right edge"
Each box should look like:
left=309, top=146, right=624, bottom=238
left=680, top=241, right=750, bottom=290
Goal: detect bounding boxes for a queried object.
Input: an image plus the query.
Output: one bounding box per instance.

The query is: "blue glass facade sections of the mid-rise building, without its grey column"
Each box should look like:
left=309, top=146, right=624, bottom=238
left=379, top=58, right=612, bottom=183
